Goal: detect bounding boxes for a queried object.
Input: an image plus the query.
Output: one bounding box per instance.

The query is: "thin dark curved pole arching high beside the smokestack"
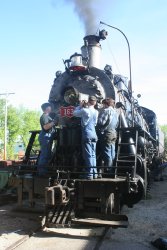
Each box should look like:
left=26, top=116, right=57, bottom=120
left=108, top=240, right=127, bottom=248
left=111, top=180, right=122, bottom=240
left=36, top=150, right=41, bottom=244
left=100, top=21, right=132, bottom=96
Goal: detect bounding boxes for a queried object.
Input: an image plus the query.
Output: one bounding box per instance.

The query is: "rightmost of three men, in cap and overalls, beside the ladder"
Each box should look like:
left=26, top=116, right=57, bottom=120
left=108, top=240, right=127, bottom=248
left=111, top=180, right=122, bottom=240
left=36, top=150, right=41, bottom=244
left=97, top=98, right=118, bottom=173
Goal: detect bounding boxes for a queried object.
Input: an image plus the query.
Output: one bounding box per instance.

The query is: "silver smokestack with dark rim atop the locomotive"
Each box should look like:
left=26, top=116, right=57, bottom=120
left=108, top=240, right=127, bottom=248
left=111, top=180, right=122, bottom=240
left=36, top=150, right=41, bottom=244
left=81, top=30, right=108, bottom=68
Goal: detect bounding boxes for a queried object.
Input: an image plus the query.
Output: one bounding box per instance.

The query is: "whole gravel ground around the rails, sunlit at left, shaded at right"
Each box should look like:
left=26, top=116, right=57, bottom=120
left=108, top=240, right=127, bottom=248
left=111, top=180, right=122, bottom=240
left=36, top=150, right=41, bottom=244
left=0, top=171, right=167, bottom=250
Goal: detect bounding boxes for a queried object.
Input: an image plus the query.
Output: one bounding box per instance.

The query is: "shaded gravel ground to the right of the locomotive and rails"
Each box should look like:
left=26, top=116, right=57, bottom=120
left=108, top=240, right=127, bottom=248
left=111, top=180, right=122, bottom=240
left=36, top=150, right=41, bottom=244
left=106, top=175, right=167, bottom=249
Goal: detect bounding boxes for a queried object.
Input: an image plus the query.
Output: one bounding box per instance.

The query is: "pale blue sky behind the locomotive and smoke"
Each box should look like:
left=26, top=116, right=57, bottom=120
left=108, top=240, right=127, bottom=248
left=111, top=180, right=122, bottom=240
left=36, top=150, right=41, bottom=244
left=0, top=0, right=167, bottom=124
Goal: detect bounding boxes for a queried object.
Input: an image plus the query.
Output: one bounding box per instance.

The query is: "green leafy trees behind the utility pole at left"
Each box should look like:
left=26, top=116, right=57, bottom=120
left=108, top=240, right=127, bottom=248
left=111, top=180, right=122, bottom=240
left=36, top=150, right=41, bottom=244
left=0, top=99, right=40, bottom=159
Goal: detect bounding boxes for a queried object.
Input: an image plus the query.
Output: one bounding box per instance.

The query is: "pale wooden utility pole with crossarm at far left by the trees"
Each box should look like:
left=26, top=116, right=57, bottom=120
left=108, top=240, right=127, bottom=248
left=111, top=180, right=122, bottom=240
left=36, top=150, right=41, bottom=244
left=0, top=93, right=15, bottom=161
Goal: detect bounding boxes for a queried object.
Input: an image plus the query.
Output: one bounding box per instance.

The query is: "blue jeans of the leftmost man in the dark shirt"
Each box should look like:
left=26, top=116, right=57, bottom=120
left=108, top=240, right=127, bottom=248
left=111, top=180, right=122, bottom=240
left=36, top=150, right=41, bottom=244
left=38, top=131, right=52, bottom=175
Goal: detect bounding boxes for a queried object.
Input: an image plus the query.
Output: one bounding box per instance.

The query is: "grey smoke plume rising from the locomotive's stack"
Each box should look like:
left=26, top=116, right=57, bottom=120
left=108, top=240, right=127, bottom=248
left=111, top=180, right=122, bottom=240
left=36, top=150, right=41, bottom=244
left=66, top=0, right=98, bottom=35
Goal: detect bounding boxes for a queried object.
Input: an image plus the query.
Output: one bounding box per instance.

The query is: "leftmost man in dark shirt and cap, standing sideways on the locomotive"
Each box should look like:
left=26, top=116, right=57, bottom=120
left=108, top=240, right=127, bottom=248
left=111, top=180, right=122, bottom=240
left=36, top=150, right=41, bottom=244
left=38, top=103, right=56, bottom=175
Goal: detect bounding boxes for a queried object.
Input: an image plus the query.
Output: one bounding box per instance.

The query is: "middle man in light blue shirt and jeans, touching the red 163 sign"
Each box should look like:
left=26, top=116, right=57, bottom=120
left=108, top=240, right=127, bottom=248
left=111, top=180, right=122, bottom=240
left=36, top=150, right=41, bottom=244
left=73, top=96, right=98, bottom=180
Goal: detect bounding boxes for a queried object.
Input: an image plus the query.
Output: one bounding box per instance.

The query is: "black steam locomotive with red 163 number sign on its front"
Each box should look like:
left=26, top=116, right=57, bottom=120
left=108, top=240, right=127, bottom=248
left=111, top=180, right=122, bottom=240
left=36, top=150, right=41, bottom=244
left=8, top=30, right=163, bottom=227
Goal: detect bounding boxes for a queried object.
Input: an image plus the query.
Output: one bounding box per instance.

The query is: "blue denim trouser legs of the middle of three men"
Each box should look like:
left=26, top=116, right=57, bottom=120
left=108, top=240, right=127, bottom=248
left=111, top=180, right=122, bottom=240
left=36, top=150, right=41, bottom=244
left=82, top=139, right=97, bottom=177
